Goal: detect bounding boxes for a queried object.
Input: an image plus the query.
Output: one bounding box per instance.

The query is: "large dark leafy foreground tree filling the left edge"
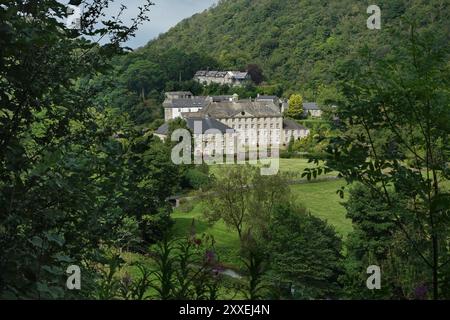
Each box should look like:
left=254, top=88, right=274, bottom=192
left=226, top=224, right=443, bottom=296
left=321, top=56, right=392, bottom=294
left=0, top=0, right=155, bottom=299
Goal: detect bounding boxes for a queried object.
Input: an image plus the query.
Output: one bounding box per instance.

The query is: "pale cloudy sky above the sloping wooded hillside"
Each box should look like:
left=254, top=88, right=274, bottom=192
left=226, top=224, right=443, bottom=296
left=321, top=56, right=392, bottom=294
left=103, top=0, right=217, bottom=49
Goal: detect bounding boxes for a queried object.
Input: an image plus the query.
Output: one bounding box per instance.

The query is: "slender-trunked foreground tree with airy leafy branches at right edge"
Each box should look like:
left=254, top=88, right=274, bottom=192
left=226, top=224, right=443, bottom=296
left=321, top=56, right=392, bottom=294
left=310, top=22, right=450, bottom=299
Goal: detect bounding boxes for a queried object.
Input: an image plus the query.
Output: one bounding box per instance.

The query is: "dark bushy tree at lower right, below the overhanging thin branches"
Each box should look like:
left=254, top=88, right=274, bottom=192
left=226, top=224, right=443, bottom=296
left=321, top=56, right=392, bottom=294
left=340, top=184, right=429, bottom=299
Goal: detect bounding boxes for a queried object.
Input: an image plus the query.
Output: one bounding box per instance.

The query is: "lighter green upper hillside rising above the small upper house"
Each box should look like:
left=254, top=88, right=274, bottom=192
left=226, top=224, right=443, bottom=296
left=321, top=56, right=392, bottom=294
left=143, top=0, right=442, bottom=95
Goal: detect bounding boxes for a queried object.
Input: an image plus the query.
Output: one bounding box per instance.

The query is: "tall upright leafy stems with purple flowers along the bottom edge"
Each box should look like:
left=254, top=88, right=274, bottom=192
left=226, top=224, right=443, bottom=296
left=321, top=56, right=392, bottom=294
left=94, top=230, right=222, bottom=300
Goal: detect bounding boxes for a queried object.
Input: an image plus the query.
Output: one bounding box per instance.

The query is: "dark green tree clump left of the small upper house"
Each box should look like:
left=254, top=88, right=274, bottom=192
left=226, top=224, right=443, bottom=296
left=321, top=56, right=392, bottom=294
left=94, top=48, right=221, bottom=126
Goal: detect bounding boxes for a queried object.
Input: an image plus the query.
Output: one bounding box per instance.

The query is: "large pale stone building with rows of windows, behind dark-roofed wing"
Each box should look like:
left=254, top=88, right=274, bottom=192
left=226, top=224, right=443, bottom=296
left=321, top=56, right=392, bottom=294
left=156, top=92, right=309, bottom=151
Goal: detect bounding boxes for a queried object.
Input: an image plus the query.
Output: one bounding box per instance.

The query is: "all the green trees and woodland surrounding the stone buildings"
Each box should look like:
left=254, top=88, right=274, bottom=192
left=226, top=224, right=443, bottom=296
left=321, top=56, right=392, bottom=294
left=0, top=0, right=450, bottom=299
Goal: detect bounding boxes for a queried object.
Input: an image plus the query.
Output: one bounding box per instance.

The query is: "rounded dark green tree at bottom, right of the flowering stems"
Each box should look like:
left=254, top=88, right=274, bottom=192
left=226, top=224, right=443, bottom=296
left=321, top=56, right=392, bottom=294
left=265, top=203, right=341, bottom=299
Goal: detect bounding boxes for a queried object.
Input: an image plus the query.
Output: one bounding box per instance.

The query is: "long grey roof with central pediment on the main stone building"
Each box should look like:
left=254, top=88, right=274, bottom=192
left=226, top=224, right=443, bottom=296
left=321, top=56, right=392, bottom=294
left=200, top=100, right=282, bottom=119
